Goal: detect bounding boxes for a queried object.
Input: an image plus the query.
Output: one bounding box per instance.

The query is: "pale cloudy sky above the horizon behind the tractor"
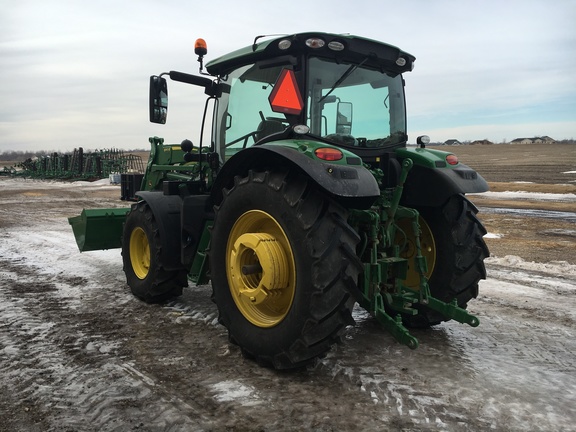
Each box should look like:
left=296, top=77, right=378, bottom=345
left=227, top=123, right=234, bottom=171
left=0, top=0, right=576, bottom=152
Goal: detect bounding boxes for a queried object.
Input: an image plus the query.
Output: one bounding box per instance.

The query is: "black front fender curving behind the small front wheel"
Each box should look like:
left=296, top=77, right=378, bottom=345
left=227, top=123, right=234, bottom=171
left=134, top=191, right=182, bottom=270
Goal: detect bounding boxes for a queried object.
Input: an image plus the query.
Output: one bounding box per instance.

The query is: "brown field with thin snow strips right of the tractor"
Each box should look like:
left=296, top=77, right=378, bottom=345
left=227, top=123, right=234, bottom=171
left=424, top=144, right=576, bottom=264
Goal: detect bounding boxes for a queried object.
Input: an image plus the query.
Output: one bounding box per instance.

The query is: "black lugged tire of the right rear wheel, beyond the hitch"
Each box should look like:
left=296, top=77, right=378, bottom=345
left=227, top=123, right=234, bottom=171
left=403, top=194, right=490, bottom=328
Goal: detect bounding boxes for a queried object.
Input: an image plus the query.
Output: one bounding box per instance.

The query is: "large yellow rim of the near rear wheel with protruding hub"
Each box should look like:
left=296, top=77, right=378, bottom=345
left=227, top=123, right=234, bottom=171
left=226, top=210, right=296, bottom=328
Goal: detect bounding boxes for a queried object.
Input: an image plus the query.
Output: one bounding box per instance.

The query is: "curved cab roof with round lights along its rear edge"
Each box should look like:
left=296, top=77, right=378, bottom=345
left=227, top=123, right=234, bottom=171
left=206, top=32, right=416, bottom=76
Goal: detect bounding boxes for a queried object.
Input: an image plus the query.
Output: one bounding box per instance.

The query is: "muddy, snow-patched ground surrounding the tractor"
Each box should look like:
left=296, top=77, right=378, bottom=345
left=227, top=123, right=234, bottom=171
left=0, top=146, right=576, bottom=431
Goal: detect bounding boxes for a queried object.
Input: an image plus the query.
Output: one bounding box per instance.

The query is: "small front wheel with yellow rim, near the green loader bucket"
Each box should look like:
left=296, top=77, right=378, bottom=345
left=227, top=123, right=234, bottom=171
left=122, top=201, right=188, bottom=303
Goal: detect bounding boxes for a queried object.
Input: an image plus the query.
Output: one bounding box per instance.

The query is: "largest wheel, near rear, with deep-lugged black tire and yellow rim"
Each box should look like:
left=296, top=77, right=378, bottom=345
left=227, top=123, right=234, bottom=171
left=210, top=172, right=361, bottom=369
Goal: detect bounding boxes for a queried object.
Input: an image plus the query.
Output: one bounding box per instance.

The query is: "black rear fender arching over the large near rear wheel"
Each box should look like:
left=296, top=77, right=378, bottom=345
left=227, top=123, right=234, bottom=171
left=212, top=144, right=380, bottom=209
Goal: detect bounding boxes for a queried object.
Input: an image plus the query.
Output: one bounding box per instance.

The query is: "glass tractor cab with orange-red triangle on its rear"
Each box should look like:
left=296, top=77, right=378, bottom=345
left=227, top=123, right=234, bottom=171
left=151, top=33, right=415, bottom=164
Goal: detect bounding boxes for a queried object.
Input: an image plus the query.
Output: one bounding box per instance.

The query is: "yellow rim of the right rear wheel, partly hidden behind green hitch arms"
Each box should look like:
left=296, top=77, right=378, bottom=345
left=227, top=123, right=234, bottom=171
left=396, top=216, right=436, bottom=289
